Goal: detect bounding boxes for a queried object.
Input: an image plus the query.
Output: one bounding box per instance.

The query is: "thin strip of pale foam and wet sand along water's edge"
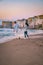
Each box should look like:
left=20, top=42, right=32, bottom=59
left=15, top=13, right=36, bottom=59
left=0, top=34, right=43, bottom=44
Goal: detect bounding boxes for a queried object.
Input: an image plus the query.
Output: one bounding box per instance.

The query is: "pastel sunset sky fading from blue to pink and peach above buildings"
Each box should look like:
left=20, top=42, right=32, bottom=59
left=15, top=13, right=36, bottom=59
left=0, top=0, right=43, bottom=20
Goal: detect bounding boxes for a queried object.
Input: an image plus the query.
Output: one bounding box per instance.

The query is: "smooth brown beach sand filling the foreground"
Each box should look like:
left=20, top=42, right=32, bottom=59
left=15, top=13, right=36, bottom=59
left=0, top=38, right=43, bottom=65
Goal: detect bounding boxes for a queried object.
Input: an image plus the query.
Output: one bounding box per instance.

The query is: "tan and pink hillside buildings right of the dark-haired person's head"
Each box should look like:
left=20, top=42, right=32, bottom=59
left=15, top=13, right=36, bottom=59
left=27, top=15, right=43, bottom=29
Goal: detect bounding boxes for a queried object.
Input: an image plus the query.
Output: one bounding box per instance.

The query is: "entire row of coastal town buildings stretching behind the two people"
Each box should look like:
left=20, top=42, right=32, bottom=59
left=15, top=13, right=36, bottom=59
left=0, top=15, right=43, bottom=29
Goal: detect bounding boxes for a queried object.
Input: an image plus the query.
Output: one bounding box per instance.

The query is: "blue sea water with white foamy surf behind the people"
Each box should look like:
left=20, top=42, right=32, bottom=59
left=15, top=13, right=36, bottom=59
left=0, top=28, right=43, bottom=43
